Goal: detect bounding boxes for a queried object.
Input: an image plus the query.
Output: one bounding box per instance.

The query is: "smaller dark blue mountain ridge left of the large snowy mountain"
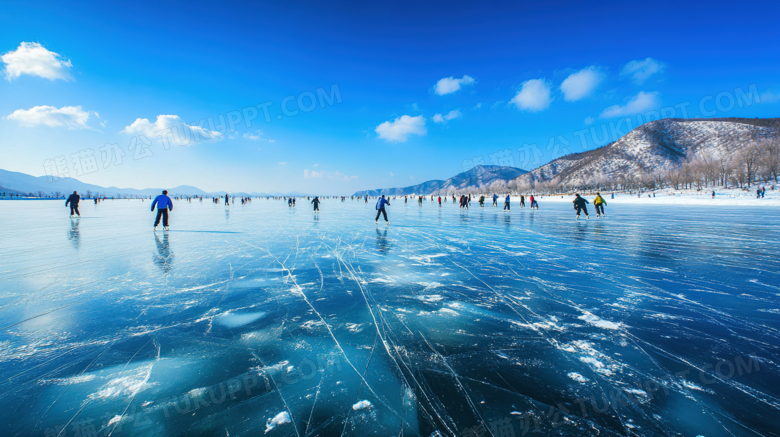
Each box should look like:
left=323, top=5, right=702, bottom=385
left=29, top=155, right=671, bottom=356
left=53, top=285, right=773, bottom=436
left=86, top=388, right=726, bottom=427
left=354, top=165, right=527, bottom=196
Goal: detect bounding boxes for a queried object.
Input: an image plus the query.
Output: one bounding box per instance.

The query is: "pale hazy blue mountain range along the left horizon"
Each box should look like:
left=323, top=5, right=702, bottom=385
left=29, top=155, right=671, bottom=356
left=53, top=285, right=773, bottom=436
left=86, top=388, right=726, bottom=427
left=0, top=170, right=308, bottom=197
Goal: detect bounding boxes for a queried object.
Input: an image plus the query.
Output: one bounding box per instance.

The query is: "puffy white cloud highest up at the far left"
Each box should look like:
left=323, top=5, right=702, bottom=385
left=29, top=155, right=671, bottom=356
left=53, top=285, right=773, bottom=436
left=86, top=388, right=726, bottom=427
left=0, top=42, right=73, bottom=81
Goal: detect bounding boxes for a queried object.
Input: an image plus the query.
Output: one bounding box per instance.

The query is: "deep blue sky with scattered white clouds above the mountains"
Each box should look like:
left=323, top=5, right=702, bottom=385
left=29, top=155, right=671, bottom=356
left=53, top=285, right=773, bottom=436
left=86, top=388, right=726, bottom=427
left=0, top=1, right=780, bottom=194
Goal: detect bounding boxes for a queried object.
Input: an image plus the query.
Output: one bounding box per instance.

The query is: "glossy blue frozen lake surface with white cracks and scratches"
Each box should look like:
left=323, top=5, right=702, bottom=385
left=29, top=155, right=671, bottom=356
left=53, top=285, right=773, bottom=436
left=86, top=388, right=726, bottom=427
left=0, top=199, right=780, bottom=437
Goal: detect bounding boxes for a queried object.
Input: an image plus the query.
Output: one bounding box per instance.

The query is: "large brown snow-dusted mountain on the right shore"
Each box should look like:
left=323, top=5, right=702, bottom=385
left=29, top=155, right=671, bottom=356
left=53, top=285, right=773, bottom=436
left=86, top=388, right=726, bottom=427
left=514, top=119, right=778, bottom=187
